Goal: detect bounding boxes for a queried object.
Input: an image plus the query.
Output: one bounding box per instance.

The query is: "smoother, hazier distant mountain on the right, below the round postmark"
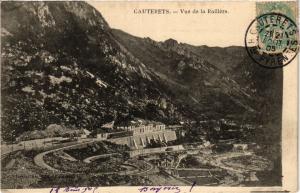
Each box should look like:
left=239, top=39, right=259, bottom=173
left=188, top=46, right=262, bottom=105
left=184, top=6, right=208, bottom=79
left=112, top=29, right=283, bottom=160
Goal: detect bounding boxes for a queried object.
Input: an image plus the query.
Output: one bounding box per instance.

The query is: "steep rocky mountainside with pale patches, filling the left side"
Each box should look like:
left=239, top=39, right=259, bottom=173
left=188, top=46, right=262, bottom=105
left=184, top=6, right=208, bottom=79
left=1, top=2, right=188, bottom=139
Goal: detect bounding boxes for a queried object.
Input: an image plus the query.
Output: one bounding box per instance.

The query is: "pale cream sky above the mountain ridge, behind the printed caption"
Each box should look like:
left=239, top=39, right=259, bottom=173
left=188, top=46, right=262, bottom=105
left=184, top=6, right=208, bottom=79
left=89, top=1, right=255, bottom=47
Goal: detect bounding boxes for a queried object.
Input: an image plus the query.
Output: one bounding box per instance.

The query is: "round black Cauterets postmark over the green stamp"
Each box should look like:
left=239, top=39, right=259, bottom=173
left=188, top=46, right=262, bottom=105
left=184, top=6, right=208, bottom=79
left=245, top=13, right=299, bottom=68
